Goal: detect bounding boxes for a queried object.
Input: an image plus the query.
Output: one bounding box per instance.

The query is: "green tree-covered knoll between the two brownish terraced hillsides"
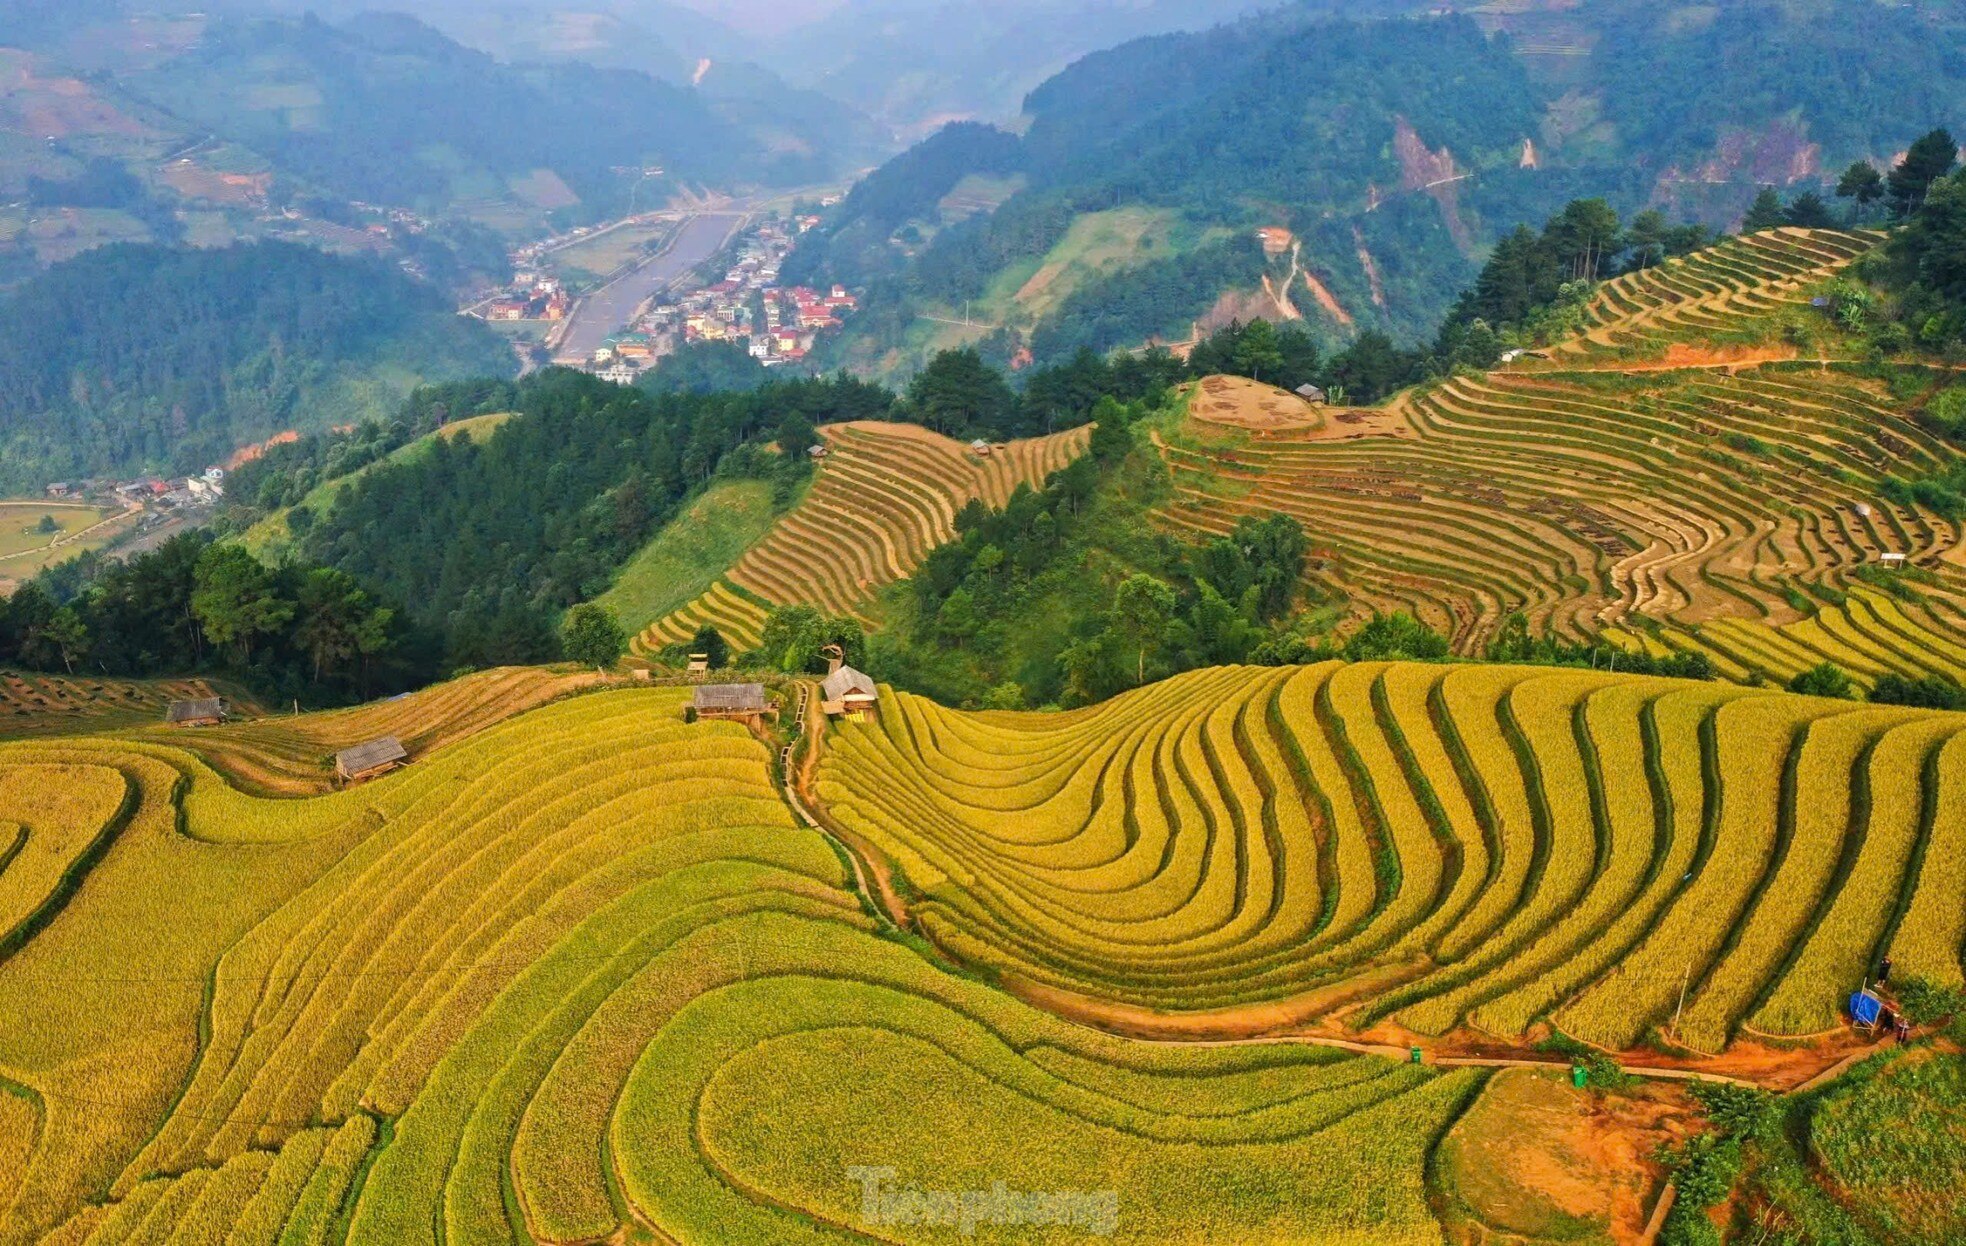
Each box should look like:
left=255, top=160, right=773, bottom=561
left=869, top=399, right=1307, bottom=708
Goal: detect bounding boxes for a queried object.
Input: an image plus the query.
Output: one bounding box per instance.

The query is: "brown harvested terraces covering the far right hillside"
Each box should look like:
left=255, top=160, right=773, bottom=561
left=1160, top=230, right=1966, bottom=680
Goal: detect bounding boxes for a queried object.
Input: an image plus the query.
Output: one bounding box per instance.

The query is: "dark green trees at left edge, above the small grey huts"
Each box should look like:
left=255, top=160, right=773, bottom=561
left=0, top=533, right=418, bottom=704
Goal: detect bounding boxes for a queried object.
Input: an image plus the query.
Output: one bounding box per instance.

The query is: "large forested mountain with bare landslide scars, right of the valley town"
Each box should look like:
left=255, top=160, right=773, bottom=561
left=794, top=0, right=1966, bottom=371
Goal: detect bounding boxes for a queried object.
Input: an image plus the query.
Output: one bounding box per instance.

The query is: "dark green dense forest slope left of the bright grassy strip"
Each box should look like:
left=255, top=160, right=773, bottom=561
left=273, top=369, right=893, bottom=666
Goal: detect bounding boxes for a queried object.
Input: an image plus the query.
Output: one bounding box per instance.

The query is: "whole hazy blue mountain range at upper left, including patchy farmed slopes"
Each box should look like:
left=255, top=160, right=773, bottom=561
left=0, top=0, right=893, bottom=236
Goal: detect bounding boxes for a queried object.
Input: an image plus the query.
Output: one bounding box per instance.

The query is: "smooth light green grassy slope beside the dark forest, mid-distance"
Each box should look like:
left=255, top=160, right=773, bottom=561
left=598, top=480, right=777, bottom=633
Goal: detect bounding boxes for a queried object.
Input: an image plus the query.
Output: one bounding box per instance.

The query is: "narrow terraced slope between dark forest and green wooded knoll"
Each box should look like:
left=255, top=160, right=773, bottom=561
left=633, top=421, right=1091, bottom=654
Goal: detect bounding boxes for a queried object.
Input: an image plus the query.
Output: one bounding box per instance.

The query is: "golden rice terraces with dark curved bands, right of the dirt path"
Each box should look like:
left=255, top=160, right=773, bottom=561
left=816, top=664, right=1966, bottom=1053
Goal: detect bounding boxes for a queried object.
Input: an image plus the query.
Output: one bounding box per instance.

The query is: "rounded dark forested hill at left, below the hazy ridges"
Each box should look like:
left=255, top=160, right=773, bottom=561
left=0, top=244, right=515, bottom=491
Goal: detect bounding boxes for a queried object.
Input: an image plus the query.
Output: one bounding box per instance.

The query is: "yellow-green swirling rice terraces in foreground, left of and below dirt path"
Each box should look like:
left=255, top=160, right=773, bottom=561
left=0, top=690, right=1482, bottom=1246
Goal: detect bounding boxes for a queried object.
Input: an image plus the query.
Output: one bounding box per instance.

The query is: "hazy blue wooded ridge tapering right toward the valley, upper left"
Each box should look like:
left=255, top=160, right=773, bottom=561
left=116, top=16, right=853, bottom=206
